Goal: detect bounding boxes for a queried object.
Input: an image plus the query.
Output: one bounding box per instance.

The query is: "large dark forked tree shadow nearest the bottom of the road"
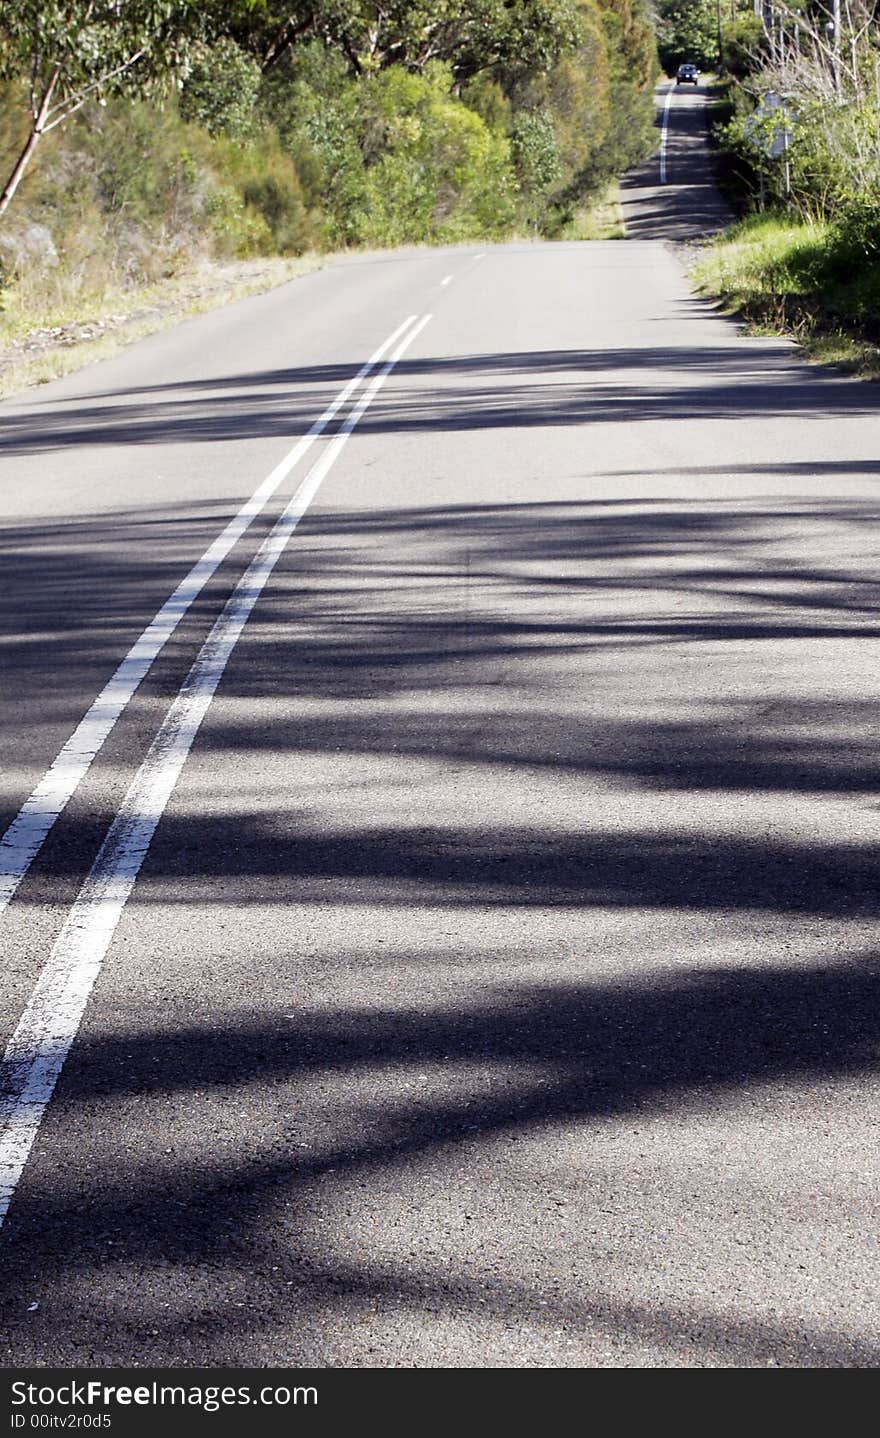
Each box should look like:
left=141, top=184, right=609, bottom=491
left=3, top=956, right=880, bottom=1366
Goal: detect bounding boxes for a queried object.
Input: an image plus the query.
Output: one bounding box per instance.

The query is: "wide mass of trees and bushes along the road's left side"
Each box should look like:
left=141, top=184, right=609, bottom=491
left=0, top=0, right=657, bottom=383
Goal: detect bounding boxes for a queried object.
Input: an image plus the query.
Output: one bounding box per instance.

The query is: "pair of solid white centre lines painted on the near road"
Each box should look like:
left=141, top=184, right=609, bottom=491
left=0, top=306, right=431, bottom=1224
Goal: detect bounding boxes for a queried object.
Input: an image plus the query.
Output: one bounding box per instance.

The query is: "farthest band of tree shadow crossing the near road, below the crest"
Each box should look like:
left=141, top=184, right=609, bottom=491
left=0, top=337, right=876, bottom=457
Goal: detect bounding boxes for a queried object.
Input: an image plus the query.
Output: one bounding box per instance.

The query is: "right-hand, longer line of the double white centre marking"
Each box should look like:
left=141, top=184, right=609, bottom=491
left=0, top=315, right=431, bottom=1224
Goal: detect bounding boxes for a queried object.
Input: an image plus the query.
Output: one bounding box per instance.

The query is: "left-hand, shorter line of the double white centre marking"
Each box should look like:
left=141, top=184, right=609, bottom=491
left=0, top=315, right=417, bottom=915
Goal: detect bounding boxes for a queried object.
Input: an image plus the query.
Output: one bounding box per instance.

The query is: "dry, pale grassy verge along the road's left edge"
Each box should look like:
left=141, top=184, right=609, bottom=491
left=0, top=255, right=324, bottom=397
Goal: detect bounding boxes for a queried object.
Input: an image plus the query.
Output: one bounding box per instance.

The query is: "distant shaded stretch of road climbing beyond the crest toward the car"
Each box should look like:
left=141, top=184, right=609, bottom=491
left=621, top=81, right=733, bottom=242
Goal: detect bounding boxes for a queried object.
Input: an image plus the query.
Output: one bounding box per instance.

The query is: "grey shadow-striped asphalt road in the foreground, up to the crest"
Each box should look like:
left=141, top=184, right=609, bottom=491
left=0, top=126, right=880, bottom=1368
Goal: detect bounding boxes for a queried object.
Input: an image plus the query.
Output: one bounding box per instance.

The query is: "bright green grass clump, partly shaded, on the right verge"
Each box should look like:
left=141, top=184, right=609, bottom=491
left=693, top=213, right=880, bottom=380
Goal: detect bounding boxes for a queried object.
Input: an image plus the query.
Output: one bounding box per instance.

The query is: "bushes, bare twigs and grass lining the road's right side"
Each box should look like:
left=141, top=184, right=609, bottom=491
left=675, top=0, right=880, bottom=378
